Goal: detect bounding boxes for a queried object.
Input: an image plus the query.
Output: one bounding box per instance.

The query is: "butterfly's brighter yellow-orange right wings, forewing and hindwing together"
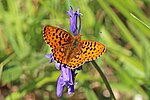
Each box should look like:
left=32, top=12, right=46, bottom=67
left=67, top=40, right=106, bottom=69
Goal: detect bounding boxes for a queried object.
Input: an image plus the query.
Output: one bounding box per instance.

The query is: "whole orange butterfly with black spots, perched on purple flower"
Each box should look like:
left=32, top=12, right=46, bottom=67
left=43, top=25, right=106, bottom=69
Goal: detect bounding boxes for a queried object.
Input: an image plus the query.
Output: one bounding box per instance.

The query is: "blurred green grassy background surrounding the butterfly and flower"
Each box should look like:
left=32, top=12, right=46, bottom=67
left=0, top=0, right=150, bottom=100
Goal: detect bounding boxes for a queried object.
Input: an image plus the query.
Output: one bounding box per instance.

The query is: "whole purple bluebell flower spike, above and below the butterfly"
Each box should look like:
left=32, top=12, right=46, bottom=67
left=46, top=7, right=82, bottom=97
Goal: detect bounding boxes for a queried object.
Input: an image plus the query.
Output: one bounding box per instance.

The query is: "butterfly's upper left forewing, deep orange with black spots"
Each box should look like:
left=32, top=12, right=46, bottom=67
left=43, top=25, right=73, bottom=49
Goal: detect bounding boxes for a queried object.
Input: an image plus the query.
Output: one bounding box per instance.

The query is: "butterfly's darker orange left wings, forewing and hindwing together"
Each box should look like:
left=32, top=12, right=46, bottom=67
left=43, top=25, right=73, bottom=63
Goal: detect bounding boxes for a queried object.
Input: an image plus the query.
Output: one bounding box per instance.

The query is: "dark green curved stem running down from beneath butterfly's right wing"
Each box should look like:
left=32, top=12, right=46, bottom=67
left=92, top=61, right=116, bottom=100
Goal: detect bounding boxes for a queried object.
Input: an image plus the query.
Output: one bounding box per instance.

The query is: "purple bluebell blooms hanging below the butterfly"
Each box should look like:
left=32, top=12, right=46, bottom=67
left=46, top=53, right=78, bottom=97
